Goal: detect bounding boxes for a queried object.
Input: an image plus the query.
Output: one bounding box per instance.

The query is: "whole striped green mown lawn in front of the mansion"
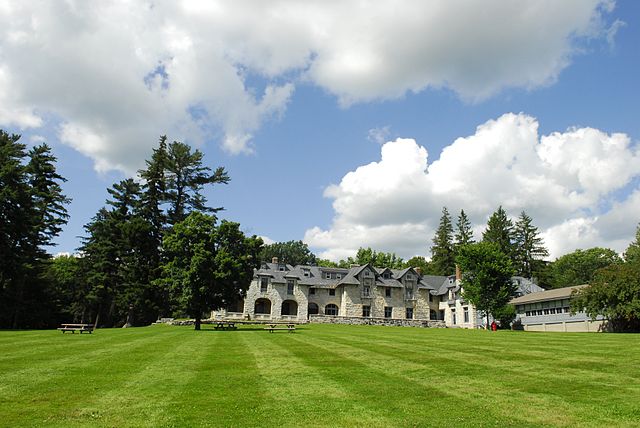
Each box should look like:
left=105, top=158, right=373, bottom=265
left=0, top=325, right=640, bottom=427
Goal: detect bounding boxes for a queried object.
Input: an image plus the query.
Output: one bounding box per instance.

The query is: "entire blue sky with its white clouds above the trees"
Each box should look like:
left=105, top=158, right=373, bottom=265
left=0, top=0, right=640, bottom=259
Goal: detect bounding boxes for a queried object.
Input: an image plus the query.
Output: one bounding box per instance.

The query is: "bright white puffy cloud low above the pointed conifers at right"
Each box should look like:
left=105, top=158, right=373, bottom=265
left=304, top=113, right=640, bottom=259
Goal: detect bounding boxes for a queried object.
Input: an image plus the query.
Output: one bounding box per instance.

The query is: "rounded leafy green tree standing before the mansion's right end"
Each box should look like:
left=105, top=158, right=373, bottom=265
left=456, top=242, right=516, bottom=326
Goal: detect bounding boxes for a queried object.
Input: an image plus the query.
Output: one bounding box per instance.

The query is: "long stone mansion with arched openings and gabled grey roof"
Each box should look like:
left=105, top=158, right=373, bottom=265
left=212, top=258, right=542, bottom=328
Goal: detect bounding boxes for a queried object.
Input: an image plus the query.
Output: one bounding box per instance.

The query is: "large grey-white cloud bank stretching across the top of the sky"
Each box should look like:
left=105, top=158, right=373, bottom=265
left=0, top=0, right=622, bottom=172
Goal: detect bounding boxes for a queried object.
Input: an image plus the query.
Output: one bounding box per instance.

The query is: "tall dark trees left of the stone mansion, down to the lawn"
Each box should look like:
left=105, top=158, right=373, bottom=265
left=0, top=132, right=262, bottom=328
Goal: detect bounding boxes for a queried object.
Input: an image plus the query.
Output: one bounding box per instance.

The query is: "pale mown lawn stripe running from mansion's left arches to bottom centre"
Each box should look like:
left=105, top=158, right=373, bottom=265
left=235, top=327, right=395, bottom=427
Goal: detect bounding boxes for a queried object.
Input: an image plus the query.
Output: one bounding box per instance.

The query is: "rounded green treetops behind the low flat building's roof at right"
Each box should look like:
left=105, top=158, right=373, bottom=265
left=540, top=247, right=622, bottom=288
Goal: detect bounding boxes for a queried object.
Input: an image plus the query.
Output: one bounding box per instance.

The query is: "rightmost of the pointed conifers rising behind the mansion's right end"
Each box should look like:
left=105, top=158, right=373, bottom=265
left=513, top=211, right=549, bottom=278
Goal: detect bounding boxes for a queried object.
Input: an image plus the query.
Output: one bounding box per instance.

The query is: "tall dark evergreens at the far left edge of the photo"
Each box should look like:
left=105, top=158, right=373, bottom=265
left=0, top=131, right=69, bottom=328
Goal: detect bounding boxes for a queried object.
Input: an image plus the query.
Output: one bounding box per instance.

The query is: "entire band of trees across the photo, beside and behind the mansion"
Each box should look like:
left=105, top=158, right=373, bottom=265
left=0, top=131, right=640, bottom=330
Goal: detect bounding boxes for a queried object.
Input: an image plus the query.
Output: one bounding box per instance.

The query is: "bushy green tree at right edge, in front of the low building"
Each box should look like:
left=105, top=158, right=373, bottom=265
left=571, top=261, right=640, bottom=332
